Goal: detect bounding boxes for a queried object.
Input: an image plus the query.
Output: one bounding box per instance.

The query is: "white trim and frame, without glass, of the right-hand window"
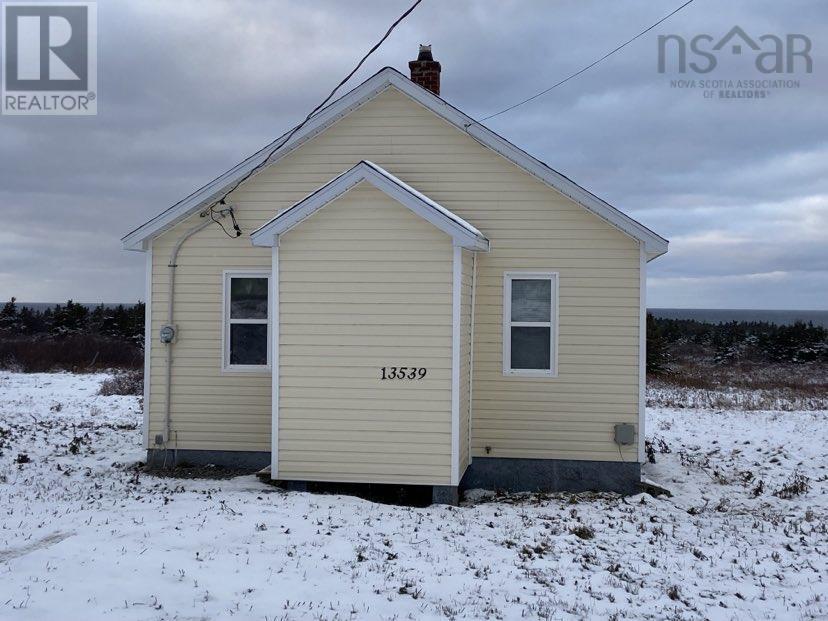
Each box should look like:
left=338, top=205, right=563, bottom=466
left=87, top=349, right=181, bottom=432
left=503, top=271, right=559, bottom=377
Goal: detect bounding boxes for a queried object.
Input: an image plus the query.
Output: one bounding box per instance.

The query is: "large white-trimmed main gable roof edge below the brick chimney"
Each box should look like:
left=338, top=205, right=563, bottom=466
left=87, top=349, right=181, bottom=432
left=121, top=67, right=668, bottom=260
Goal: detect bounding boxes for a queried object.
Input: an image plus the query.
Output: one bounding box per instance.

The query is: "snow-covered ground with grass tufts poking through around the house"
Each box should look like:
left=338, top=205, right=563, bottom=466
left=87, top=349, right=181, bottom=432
left=0, top=373, right=828, bottom=621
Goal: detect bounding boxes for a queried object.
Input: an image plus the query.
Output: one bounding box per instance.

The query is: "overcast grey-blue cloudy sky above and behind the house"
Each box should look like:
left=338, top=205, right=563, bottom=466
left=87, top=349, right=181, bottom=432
left=0, top=0, right=828, bottom=309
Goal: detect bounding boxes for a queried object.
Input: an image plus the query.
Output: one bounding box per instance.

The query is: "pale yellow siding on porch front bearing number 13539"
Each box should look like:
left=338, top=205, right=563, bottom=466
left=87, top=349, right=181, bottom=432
left=279, top=182, right=452, bottom=485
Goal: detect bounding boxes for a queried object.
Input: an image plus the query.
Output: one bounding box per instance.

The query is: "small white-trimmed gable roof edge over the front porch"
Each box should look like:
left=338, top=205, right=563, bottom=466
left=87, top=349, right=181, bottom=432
left=250, top=160, right=489, bottom=251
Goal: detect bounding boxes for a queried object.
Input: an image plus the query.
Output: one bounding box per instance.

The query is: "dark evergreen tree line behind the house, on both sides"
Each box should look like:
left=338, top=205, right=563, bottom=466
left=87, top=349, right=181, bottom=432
left=0, top=298, right=828, bottom=374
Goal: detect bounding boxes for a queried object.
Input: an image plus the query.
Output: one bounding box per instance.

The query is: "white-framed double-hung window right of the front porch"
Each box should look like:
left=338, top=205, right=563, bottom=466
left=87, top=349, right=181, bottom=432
left=503, top=272, right=558, bottom=377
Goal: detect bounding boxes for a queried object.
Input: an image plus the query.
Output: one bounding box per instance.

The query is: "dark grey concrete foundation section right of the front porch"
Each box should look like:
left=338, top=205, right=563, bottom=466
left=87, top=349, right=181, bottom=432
left=460, top=457, right=641, bottom=494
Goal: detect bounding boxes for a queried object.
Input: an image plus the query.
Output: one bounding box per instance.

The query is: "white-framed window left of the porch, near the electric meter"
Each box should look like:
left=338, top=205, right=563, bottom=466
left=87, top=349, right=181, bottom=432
left=223, top=272, right=270, bottom=371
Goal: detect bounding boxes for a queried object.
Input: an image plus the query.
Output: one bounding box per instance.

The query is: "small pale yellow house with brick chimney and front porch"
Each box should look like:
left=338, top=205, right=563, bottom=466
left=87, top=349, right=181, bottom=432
left=123, top=47, right=667, bottom=502
